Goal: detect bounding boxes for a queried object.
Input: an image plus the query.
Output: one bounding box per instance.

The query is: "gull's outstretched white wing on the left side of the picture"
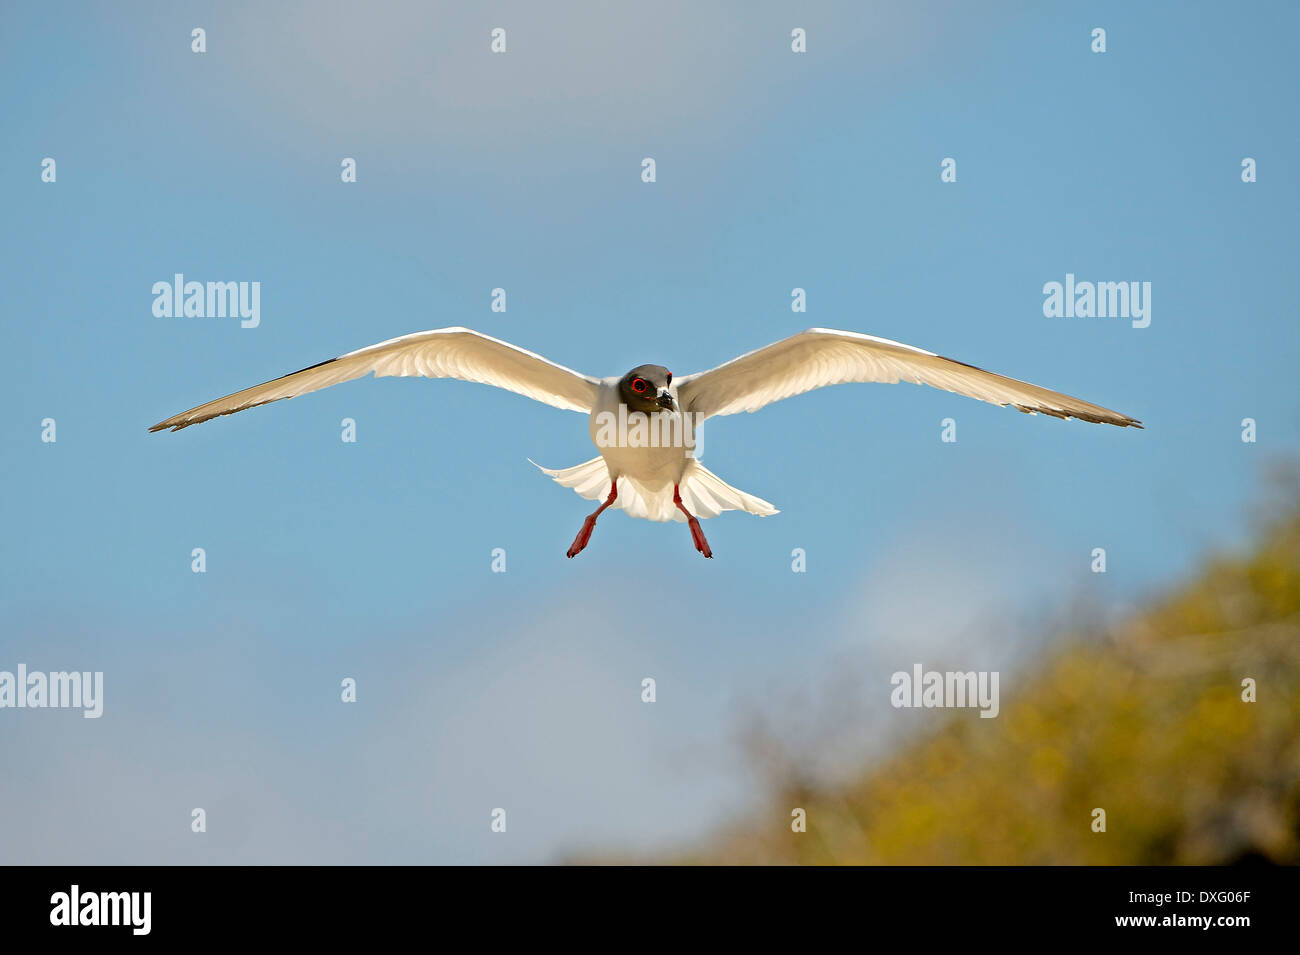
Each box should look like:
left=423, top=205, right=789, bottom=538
left=150, top=327, right=599, bottom=431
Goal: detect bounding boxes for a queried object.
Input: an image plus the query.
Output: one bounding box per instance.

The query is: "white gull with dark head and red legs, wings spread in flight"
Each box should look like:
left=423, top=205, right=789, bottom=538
left=150, top=327, right=1141, bottom=557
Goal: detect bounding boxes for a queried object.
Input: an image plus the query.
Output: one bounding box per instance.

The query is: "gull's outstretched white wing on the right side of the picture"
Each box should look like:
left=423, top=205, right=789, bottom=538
left=677, top=329, right=1141, bottom=427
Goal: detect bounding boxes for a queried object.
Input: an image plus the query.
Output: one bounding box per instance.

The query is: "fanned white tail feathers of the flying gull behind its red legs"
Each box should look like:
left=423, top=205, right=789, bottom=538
left=528, top=456, right=780, bottom=521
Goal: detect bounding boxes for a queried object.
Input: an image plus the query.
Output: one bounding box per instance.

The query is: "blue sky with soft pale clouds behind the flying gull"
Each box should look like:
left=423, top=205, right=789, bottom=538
left=0, top=3, right=1300, bottom=863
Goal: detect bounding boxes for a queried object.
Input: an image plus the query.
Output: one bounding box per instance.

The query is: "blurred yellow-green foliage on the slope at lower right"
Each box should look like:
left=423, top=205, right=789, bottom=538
left=670, top=475, right=1300, bottom=865
